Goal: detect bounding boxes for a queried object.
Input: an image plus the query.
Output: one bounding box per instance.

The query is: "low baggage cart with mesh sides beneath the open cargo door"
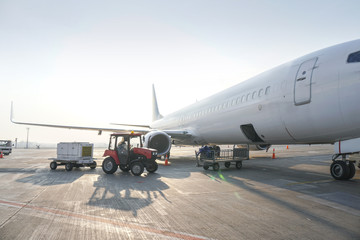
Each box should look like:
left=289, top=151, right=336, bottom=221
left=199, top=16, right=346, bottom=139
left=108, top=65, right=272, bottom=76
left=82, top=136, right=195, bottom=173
left=195, top=146, right=249, bottom=171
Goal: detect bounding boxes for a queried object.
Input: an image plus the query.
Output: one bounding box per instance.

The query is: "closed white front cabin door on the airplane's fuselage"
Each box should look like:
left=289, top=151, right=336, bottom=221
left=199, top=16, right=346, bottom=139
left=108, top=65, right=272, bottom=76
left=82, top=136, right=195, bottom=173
left=294, top=58, right=317, bottom=105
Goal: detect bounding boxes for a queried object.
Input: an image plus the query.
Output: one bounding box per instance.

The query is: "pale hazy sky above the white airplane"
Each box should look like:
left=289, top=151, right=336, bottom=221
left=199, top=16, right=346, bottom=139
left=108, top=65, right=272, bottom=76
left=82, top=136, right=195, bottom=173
left=0, top=0, right=360, bottom=143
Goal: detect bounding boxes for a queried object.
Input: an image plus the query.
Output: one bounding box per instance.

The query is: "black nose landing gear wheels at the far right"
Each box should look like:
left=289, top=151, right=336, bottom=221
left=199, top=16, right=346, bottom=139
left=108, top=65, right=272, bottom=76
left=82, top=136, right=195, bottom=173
left=330, top=154, right=355, bottom=180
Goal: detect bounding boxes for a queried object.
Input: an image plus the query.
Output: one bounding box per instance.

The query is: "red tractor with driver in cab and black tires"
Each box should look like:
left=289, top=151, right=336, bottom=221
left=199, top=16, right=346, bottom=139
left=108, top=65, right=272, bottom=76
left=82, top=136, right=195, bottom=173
left=102, top=132, right=158, bottom=176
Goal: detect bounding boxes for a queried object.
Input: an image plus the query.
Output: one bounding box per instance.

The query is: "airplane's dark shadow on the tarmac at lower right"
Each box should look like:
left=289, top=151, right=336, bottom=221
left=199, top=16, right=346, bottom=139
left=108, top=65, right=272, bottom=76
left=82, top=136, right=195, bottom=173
left=203, top=157, right=360, bottom=239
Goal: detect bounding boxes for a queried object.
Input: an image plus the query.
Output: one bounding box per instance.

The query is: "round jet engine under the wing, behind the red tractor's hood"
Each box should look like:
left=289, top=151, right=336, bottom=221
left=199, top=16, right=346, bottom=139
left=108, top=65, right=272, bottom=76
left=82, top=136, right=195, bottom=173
left=144, top=131, right=171, bottom=156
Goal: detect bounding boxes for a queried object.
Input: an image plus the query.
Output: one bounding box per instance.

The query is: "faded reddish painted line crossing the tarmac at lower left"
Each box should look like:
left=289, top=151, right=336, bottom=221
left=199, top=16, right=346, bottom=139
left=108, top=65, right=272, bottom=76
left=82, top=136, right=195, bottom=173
left=0, top=199, right=210, bottom=240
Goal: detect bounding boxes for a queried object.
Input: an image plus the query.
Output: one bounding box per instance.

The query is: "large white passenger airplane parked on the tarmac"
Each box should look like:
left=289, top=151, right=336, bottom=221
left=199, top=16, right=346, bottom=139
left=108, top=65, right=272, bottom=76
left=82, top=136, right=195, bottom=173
left=10, top=39, right=360, bottom=180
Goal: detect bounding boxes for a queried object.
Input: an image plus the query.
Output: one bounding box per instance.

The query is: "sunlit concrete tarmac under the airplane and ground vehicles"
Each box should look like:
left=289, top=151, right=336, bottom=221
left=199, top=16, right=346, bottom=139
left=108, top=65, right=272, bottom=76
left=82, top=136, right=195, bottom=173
left=0, top=145, right=360, bottom=240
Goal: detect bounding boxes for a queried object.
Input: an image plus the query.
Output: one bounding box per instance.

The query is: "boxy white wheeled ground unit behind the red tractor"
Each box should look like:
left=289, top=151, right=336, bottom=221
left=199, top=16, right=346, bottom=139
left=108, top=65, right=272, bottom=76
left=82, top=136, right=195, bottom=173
left=49, top=142, right=97, bottom=171
